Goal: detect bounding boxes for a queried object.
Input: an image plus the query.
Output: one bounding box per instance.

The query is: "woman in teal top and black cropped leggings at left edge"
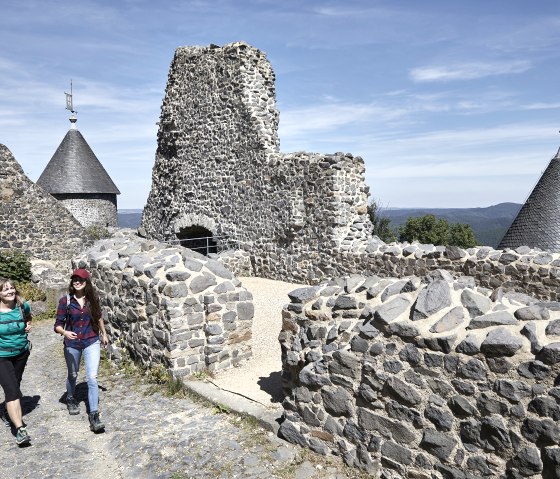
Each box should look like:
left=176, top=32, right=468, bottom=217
left=0, top=278, right=32, bottom=446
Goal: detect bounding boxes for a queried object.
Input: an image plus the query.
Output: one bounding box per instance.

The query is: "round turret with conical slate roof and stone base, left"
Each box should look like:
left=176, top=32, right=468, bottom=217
left=37, top=115, right=120, bottom=227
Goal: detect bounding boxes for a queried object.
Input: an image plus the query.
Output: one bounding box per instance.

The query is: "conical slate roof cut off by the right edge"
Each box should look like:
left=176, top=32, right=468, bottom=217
left=498, top=149, right=560, bottom=252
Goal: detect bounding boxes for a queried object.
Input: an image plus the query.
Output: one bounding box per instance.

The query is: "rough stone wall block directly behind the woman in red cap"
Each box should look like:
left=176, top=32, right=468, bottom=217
left=73, top=231, right=254, bottom=377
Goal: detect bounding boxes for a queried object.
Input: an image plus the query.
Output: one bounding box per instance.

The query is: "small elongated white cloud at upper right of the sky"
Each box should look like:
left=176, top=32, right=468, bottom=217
left=410, top=60, right=531, bottom=82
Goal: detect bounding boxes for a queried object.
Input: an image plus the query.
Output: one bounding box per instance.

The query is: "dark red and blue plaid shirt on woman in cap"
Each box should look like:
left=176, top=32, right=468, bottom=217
left=54, top=296, right=99, bottom=349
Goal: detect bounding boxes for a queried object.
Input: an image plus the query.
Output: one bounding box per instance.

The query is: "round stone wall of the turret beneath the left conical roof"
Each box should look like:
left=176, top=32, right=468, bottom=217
left=55, top=193, right=118, bottom=228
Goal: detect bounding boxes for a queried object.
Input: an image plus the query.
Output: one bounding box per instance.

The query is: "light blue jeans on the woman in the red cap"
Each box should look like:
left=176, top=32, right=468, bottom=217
left=64, top=341, right=101, bottom=413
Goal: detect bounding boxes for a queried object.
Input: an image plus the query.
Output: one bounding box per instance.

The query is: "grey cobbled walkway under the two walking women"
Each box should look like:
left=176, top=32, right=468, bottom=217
left=0, top=280, right=364, bottom=479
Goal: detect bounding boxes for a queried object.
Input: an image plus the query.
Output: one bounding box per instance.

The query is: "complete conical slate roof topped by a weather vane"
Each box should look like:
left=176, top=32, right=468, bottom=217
left=37, top=119, right=120, bottom=195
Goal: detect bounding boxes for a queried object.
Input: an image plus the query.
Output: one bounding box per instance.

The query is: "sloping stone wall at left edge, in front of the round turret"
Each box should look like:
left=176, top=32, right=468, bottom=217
left=0, top=144, right=93, bottom=261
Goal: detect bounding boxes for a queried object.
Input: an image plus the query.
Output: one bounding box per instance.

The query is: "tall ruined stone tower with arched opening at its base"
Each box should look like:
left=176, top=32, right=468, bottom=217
left=142, top=42, right=371, bottom=281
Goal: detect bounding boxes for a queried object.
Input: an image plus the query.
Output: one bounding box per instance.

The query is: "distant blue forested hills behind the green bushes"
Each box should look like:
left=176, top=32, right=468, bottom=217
left=379, top=203, right=522, bottom=248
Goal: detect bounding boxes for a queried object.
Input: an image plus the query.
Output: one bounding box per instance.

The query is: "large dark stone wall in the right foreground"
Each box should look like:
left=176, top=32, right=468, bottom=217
left=279, top=270, right=560, bottom=479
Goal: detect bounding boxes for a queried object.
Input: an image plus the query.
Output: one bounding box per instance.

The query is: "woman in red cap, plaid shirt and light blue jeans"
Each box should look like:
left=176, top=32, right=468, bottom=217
left=54, top=268, right=107, bottom=433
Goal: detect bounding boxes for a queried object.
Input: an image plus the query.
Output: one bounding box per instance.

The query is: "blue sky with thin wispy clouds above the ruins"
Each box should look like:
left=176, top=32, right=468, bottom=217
left=0, top=0, right=560, bottom=209
